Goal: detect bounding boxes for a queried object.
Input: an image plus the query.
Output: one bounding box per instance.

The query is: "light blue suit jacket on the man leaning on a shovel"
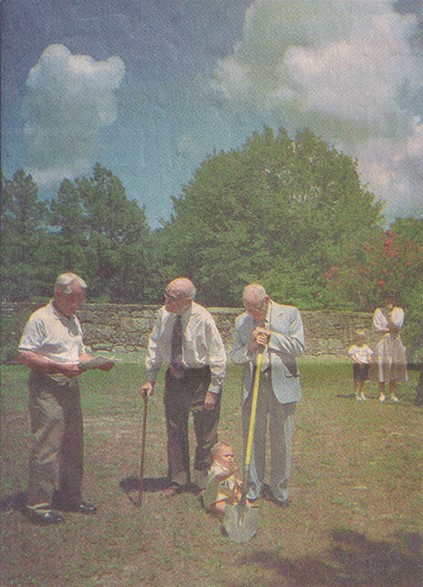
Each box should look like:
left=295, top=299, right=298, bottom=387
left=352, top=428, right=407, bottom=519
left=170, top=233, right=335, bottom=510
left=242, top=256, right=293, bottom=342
left=231, top=301, right=305, bottom=404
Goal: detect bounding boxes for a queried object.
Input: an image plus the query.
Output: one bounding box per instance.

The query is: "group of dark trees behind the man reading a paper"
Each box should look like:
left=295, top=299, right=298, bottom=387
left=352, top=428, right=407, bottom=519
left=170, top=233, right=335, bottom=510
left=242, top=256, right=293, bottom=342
left=2, top=164, right=151, bottom=302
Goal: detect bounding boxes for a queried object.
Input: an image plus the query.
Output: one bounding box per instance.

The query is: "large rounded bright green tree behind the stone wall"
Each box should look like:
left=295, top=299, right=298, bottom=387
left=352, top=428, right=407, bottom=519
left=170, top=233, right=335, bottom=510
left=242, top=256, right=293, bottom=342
left=157, top=128, right=382, bottom=308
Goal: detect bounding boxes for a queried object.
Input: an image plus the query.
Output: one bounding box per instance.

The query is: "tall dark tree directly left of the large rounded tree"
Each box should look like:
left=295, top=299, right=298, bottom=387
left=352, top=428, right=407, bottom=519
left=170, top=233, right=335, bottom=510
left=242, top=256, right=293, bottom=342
left=74, top=163, right=151, bottom=302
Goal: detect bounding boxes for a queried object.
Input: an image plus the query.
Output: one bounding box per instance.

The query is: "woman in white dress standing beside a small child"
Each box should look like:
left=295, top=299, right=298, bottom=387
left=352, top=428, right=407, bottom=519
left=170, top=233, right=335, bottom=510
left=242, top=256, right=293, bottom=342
left=373, top=293, right=407, bottom=403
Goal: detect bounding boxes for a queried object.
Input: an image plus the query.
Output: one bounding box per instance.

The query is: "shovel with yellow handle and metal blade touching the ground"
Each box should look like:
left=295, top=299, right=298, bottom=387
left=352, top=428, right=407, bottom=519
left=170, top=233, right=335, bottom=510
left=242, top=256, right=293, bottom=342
left=223, top=351, right=263, bottom=542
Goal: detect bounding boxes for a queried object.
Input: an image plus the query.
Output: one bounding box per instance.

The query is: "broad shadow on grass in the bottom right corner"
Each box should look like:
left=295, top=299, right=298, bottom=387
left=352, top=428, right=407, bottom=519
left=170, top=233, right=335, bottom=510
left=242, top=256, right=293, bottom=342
left=233, top=530, right=423, bottom=587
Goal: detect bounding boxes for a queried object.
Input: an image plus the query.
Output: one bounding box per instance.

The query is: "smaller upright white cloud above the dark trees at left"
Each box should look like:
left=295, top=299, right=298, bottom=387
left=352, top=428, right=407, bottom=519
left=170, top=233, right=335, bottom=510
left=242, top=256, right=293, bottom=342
left=24, top=45, right=125, bottom=187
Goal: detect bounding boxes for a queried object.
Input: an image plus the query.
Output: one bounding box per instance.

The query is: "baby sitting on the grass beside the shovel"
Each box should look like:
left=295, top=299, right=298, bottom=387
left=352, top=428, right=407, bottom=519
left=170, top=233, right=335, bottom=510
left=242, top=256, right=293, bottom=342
left=203, top=442, right=242, bottom=515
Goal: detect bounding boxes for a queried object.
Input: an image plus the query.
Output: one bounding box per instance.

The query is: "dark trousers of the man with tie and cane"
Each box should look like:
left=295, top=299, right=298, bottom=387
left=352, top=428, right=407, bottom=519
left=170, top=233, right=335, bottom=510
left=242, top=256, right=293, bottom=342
left=164, top=367, right=220, bottom=489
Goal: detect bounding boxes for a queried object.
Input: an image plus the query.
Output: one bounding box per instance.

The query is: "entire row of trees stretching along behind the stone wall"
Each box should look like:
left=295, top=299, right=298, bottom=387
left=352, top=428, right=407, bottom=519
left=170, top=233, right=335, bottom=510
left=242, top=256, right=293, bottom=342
left=1, top=127, right=423, bottom=352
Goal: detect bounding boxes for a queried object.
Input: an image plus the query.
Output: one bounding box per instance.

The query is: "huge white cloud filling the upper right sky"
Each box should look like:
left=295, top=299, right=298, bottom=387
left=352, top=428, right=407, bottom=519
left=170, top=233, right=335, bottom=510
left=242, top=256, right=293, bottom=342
left=211, top=0, right=423, bottom=217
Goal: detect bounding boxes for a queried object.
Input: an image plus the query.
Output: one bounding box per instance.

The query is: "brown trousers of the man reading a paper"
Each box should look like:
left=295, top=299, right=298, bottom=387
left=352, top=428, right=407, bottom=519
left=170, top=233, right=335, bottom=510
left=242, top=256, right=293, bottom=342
left=28, top=372, right=84, bottom=505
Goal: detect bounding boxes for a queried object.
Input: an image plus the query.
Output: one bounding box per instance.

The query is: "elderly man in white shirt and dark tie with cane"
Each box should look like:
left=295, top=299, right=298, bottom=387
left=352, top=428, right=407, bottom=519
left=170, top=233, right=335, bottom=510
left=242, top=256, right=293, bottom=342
left=141, top=277, right=226, bottom=497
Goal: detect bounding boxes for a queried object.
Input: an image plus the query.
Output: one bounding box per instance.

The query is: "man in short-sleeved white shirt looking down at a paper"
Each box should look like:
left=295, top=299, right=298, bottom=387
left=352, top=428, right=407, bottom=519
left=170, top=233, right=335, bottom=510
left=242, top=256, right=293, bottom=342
left=18, top=273, right=113, bottom=525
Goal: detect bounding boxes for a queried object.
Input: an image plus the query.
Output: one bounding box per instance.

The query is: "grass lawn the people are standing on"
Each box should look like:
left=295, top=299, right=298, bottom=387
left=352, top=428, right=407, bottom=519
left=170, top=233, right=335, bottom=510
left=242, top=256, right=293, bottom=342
left=0, top=359, right=422, bottom=587
